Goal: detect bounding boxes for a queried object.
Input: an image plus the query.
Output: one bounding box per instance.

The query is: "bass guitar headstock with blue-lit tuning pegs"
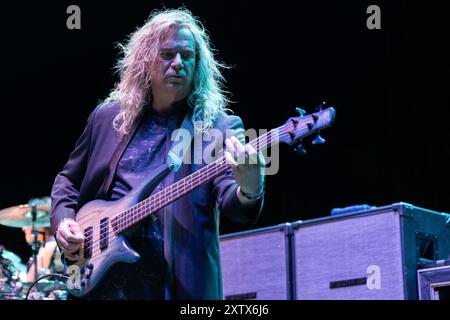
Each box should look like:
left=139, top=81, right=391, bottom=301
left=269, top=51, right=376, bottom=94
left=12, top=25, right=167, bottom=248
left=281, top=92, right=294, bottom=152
left=279, top=102, right=336, bottom=153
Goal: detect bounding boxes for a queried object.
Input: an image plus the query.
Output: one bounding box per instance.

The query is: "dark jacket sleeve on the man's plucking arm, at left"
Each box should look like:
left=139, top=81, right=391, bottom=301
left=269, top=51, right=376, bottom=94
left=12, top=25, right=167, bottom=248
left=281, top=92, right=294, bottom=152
left=50, top=109, right=97, bottom=233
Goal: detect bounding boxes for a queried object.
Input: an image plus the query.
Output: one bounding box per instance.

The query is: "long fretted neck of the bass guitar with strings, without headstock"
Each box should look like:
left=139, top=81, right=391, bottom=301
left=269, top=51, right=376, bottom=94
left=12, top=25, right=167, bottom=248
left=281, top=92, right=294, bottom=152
left=111, top=125, right=289, bottom=233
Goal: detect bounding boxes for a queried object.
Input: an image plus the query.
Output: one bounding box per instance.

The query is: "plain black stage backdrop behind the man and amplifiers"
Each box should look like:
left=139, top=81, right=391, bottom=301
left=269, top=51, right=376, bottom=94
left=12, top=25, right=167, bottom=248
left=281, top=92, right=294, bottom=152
left=0, top=0, right=450, bottom=259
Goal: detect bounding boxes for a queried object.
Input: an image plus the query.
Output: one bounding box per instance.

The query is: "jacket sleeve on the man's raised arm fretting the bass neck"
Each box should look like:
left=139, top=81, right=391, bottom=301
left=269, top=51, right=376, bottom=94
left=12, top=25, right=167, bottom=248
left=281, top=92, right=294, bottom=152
left=213, top=116, right=264, bottom=223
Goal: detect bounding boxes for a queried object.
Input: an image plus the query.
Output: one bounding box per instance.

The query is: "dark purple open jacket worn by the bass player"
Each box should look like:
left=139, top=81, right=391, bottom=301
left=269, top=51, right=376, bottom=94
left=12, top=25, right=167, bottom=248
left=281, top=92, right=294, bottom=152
left=51, top=103, right=263, bottom=299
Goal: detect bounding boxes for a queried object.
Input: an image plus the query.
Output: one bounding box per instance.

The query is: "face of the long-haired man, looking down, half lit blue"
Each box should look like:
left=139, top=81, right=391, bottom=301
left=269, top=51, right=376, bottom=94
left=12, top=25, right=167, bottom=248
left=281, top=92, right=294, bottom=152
left=152, top=28, right=195, bottom=102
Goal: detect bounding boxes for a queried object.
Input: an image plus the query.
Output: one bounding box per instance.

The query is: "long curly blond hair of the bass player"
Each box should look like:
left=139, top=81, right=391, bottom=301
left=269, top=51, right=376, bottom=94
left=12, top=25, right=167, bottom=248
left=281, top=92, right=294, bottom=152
left=104, top=8, right=230, bottom=134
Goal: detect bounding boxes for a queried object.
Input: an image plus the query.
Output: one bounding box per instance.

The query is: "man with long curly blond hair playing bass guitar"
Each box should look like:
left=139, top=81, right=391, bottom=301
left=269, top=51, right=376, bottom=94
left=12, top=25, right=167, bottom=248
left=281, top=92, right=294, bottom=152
left=51, top=9, right=264, bottom=299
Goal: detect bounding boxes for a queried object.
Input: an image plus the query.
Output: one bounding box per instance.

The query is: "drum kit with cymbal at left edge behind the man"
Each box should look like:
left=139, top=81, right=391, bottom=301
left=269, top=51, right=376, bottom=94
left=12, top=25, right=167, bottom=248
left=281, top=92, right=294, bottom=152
left=0, top=198, right=68, bottom=300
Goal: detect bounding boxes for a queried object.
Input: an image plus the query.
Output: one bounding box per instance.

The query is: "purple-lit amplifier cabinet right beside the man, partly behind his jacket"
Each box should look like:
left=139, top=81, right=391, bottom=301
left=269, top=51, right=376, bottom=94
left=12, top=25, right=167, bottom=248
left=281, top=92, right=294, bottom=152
left=220, top=223, right=293, bottom=300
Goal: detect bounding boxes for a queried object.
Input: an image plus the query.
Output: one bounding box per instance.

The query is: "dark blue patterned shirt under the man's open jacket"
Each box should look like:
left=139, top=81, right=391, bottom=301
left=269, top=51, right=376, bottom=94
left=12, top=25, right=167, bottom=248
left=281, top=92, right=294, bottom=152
left=100, top=109, right=182, bottom=299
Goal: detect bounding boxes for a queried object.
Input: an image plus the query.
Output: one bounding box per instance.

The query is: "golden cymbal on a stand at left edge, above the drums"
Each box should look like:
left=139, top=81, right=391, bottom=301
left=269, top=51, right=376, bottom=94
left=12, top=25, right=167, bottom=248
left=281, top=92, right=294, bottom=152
left=0, top=203, right=50, bottom=228
